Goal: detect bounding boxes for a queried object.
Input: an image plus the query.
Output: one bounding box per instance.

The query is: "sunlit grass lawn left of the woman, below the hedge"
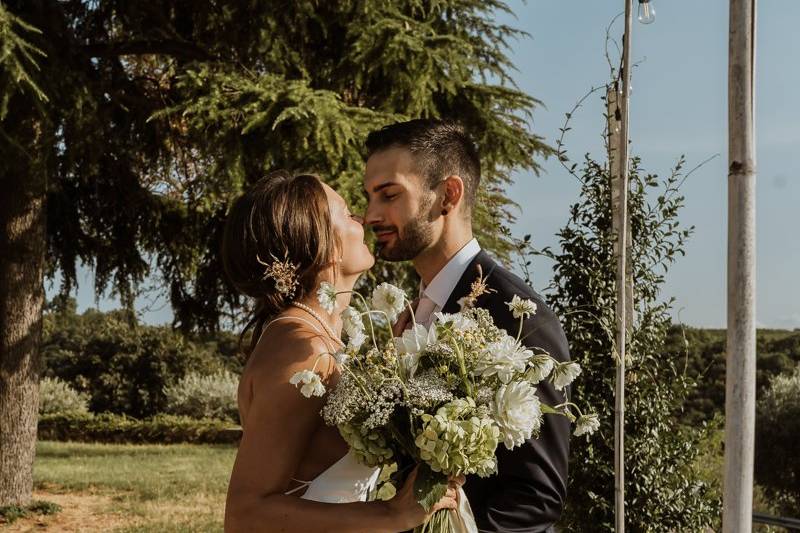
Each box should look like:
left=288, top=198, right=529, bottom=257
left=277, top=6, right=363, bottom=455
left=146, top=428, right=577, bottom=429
left=4, top=441, right=236, bottom=533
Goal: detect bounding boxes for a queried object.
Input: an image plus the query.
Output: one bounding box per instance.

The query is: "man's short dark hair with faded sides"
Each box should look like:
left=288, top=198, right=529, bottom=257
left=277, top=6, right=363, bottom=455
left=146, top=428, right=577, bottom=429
left=366, top=118, right=481, bottom=210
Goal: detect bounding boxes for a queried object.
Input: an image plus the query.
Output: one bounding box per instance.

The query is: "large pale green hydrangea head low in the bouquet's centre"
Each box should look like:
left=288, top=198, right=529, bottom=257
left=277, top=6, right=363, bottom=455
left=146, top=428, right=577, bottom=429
left=415, top=398, right=500, bottom=477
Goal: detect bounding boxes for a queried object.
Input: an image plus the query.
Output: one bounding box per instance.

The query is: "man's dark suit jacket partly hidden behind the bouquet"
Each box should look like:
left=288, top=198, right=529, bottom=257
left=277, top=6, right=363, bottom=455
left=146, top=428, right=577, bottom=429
left=443, top=251, right=570, bottom=533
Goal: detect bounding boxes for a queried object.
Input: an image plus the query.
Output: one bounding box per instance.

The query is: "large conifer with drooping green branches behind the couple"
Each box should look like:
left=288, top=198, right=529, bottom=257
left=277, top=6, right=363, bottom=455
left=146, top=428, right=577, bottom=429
left=0, top=0, right=549, bottom=505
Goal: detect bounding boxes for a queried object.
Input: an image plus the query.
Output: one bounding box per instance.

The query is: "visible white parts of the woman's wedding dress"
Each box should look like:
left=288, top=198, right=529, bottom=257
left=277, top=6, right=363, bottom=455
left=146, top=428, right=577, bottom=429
left=268, top=317, right=478, bottom=533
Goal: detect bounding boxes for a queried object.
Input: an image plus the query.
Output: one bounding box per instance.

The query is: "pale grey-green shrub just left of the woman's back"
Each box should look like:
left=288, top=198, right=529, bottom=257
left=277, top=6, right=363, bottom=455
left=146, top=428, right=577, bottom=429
left=164, top=370, right=239, bottom=421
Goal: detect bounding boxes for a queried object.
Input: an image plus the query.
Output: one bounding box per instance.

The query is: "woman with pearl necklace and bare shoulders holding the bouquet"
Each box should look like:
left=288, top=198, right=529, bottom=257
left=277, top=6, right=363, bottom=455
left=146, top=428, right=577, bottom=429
left=222, top=172, right=464, bottom=533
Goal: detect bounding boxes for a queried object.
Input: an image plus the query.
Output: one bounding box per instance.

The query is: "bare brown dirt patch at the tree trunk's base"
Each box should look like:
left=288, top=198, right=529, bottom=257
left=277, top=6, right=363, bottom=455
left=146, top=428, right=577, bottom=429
left=0, top=491, right=134, bottom=533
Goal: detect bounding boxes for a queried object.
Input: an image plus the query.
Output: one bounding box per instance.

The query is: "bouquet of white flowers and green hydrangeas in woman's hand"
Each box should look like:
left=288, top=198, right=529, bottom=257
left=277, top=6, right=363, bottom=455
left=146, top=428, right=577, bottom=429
left=291, top=277, right=599, bottom=533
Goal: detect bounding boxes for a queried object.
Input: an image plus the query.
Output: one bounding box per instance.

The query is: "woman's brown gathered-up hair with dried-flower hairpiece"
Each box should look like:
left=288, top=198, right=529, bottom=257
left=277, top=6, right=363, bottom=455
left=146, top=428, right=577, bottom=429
left=222, top=170, right=337, bottom=355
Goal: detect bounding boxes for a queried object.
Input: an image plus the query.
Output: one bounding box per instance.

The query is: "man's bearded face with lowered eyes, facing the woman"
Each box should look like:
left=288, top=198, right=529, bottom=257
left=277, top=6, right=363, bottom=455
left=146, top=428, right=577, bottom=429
left=364, top=148, right=437, bottom=261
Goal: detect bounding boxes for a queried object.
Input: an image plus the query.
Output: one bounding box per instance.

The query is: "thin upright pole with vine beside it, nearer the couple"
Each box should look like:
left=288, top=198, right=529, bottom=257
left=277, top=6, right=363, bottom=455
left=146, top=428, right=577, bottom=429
left=614, top=0, right=633, bottom=533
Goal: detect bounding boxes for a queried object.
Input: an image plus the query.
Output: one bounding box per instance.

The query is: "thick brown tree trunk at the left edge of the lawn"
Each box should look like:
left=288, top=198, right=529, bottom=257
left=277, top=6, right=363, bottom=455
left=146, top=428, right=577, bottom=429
left=0, top=4, right=51, bottom=507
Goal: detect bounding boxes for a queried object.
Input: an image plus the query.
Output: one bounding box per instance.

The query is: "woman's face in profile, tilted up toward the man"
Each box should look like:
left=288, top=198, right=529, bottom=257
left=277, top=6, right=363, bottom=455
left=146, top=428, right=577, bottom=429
left=322, top=183, right=375, bottom=277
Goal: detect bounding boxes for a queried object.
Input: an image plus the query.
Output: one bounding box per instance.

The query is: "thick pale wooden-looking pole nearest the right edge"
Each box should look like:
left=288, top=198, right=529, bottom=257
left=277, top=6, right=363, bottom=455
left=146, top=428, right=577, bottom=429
left=722, top=0, right=756, bottom=533
